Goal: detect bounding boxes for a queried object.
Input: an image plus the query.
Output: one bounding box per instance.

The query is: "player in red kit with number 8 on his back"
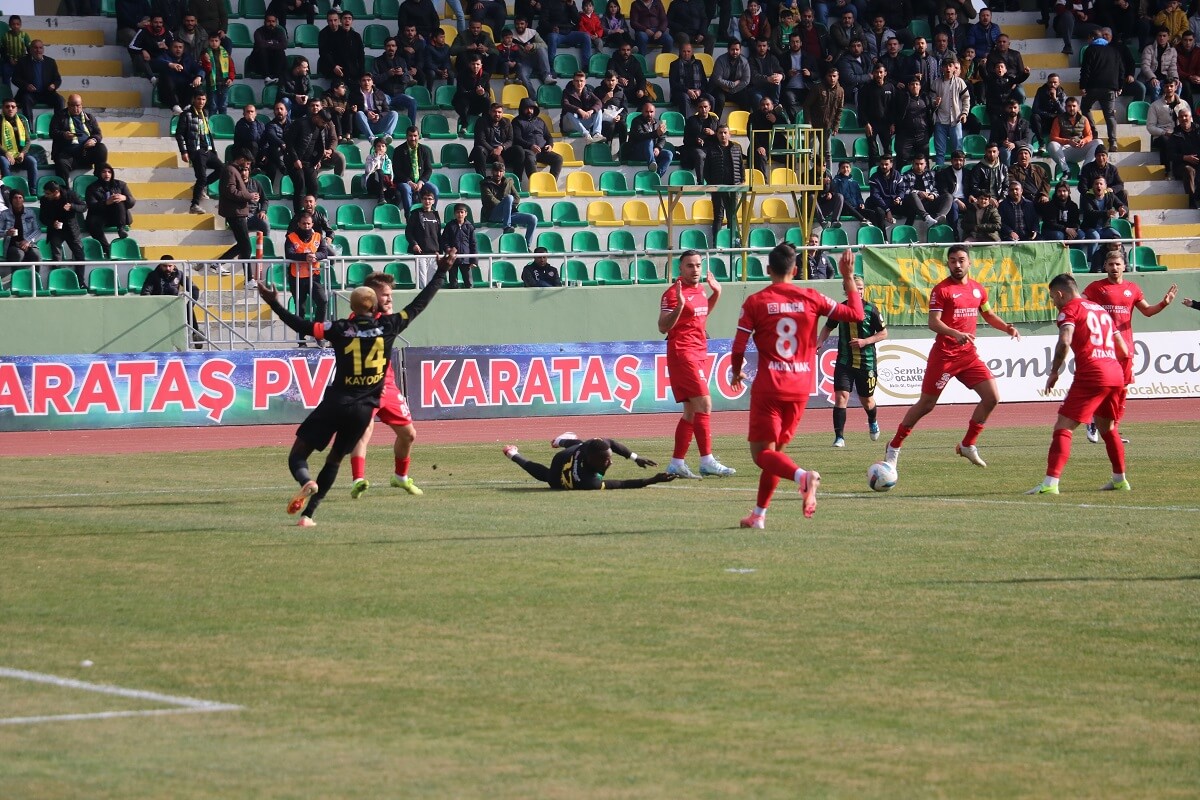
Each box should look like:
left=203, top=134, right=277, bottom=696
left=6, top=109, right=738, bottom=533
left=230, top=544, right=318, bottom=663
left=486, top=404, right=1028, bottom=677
left=731, top=242, right=863, bottom=528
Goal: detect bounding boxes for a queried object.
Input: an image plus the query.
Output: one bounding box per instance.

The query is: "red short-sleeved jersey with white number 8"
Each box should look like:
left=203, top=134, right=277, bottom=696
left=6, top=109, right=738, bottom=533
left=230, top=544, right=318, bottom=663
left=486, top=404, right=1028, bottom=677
left=738, top=283, right=838, bottom=401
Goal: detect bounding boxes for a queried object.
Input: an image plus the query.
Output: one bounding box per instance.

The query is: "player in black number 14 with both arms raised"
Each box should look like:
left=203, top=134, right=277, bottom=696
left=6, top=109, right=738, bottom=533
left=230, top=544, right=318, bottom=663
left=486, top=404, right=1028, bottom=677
left=258, top=258, right=451, bottom=528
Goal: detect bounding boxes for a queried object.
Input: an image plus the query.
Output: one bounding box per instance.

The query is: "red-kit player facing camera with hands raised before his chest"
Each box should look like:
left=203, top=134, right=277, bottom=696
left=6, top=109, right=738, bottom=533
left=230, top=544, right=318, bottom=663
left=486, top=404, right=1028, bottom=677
left=659, top=249, right=736, bottom=479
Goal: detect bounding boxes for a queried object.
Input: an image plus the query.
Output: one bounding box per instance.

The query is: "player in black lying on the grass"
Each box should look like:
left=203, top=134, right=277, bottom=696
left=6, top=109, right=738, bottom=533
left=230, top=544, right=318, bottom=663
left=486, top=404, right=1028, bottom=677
left=504, top=433, right=678, bottom=489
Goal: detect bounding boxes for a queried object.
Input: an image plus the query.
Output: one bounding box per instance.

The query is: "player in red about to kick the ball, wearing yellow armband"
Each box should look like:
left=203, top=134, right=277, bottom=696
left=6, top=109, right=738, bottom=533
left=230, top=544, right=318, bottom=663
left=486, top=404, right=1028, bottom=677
left=883, top=245, right=1021, bottom=467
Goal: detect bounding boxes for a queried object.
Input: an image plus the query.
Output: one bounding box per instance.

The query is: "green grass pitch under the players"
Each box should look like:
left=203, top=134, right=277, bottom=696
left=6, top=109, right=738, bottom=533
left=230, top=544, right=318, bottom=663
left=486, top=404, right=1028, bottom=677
left=0, top=415, right=1200, bottom=799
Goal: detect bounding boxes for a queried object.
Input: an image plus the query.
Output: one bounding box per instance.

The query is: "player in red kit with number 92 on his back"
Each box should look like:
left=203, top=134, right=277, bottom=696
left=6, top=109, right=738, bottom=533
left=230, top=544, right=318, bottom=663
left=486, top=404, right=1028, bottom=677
left=1026, top=273, right=1130, bottom=494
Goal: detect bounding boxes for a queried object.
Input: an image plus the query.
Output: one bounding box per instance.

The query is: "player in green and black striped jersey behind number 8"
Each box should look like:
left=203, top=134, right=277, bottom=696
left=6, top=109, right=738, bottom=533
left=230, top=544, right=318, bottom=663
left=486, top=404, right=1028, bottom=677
left=817, top=275, right=888, bottom=447
